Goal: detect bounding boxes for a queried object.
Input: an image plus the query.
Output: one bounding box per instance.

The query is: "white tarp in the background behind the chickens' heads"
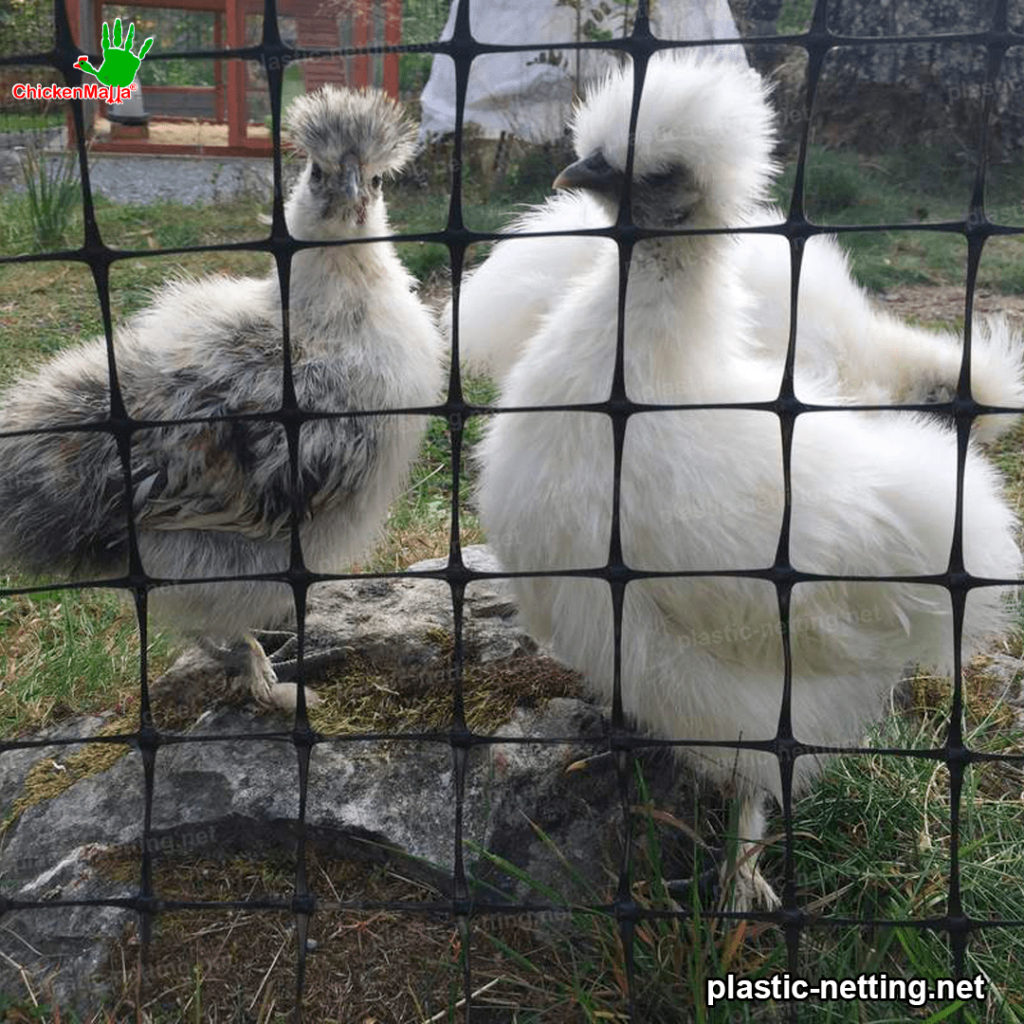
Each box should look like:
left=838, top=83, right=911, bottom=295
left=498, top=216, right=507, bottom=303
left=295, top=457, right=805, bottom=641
left=421, top=0, right=746, bottom=142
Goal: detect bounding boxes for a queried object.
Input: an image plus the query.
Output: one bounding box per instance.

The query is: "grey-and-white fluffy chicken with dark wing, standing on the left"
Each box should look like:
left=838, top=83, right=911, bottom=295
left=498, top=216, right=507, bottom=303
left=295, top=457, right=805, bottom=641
left=0, top=86, right=441, bottom=706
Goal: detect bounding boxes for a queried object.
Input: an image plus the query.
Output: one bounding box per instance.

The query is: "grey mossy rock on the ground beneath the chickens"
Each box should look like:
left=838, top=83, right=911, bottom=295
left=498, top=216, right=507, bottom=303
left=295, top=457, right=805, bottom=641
left=0, top=548, right=688, bottom=1010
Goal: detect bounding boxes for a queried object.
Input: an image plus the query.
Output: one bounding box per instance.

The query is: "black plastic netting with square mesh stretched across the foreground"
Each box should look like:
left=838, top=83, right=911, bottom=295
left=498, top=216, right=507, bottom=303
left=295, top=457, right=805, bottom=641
left=0, top=0, right=1024, bottom=1021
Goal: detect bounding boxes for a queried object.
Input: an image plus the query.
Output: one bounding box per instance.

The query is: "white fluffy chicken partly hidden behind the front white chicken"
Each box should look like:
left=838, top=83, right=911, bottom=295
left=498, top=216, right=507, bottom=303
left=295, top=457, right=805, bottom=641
left=452, top=181, right=1024, bottom=441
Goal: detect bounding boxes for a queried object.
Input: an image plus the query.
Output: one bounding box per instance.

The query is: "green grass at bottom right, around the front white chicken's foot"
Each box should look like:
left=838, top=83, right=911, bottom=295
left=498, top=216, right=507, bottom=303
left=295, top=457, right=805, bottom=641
left=458, top=688, right=1024, bottom=1024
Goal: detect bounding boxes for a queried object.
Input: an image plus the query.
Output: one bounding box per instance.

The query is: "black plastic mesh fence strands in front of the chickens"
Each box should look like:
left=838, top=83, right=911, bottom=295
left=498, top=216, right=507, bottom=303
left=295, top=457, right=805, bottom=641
left=0, top=0, right=1024, bottom=1024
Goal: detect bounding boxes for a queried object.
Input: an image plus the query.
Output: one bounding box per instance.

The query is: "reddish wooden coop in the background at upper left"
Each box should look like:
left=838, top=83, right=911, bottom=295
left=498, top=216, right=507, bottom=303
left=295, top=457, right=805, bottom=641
left=68, top=0, right=401, bottom=156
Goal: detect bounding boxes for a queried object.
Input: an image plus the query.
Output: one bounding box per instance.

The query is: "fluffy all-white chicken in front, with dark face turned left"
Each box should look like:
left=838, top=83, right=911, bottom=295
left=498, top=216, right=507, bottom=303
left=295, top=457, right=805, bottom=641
left=475, top=57, right=1022, bottom=904
